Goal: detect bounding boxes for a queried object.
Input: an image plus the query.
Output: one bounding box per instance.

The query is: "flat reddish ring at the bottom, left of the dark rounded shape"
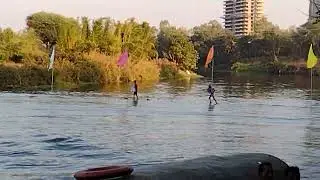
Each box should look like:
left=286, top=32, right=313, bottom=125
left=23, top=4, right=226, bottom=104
left=74, top=166, right=133, bottom=180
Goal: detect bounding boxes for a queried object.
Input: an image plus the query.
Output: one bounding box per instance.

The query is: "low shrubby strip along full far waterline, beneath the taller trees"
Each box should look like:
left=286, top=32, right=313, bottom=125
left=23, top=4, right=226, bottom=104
left=0, top=53, right=320, bottom=91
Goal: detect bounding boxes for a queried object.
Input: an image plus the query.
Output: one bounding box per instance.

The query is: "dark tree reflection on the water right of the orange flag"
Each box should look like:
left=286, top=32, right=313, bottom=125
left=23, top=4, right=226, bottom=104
left=219, top=74, right=320, bottom=100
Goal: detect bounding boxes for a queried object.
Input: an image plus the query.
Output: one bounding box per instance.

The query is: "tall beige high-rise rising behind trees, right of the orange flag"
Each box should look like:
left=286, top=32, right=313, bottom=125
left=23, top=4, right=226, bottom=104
left=224, top=0, right=264, bottom=37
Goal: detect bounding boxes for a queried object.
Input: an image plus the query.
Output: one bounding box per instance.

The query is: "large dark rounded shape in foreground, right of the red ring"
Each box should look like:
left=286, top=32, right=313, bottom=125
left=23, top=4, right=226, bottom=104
left=126, top=154, right=300, bottom=180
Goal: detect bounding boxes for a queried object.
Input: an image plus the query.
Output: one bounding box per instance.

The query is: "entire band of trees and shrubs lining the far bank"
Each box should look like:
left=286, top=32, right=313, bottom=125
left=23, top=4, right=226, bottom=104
left=0, top=12, right=320, bottom=89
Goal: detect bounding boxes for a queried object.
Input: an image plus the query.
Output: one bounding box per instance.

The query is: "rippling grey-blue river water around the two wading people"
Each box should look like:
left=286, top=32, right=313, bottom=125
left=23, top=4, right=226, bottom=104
left=0, top=75, right=320, bottom=180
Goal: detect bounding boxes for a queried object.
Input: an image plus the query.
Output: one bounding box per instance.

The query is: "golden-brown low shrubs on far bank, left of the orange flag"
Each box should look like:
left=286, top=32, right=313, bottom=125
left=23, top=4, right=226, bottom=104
left=0, top=53, right=198, bottom=91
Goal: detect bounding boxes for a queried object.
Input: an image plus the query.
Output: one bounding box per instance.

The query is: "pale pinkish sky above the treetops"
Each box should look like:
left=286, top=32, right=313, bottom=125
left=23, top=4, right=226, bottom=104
left=0, top=0, right=309, bottom=30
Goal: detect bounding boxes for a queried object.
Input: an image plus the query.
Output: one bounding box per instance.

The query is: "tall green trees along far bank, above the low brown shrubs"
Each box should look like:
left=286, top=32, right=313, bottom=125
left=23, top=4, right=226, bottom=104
left=0, top=12, right=320, bottom=75
